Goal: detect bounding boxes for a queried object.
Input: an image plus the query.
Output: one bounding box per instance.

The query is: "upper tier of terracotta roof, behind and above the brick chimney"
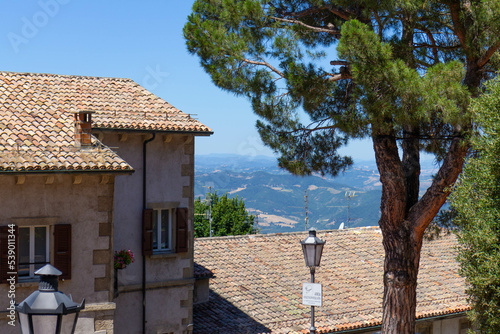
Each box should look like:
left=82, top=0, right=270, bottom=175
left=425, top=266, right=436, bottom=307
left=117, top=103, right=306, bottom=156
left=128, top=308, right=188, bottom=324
left=0, top=72, right=212, bottom=134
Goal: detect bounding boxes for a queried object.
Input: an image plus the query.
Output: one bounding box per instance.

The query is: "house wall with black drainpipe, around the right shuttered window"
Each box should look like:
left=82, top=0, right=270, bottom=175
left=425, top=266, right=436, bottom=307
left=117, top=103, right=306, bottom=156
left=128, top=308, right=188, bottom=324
left=100, top=132, right=194, bottom=334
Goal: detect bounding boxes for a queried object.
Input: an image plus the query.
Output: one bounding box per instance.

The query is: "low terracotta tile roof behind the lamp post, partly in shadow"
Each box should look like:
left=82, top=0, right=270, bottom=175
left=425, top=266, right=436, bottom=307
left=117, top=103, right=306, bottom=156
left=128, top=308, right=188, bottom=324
left=194, top=228, right=468, bottom=334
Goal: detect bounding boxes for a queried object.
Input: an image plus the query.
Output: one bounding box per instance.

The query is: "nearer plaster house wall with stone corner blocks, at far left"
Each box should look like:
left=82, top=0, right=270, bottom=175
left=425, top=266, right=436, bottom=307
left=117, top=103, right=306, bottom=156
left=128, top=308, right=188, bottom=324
left=0, top=173, right=114, bottom=334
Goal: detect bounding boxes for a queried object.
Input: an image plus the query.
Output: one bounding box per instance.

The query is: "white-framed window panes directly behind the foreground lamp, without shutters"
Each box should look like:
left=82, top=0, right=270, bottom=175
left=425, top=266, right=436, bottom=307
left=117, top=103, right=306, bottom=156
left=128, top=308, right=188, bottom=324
left=18, top=226, right=50, bottom=280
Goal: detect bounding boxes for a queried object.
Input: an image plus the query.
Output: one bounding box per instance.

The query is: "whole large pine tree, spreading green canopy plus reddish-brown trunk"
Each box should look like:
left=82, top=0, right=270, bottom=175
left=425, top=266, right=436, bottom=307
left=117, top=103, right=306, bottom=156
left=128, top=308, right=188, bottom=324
left=184, top=0, right=500, bottom=334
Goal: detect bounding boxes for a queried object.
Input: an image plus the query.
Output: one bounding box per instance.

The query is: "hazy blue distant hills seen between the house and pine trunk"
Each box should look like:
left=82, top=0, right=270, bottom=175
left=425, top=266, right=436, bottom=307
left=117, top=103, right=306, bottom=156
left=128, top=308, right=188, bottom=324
left=195, top=155, right=432, bottom=233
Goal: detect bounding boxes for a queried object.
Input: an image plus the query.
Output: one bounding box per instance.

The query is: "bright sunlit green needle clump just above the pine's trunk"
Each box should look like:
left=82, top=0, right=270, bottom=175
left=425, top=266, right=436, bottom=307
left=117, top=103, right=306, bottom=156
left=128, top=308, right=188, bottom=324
left=337, top=20, right=470, bottom=139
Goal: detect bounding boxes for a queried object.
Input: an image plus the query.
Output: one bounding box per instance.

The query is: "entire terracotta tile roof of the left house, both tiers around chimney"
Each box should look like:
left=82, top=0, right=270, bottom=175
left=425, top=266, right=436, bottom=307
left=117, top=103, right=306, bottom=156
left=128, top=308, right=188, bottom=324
left=0, top=72, right=211, bottom=172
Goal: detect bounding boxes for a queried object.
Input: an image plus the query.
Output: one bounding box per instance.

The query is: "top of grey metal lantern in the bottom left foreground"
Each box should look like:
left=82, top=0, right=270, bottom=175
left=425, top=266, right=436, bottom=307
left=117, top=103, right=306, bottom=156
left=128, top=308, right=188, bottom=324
left=16, top=264, right=85, bottom=334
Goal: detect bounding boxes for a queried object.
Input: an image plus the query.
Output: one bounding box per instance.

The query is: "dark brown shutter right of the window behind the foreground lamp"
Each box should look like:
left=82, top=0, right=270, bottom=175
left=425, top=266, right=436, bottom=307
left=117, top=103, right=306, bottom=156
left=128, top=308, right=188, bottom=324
left=54, top=224, right=71, bottom=279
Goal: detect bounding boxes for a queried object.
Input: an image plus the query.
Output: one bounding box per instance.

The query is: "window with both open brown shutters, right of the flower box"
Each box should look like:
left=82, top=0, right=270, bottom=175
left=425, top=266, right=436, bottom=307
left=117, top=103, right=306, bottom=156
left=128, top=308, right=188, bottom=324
left=142, top=208, right=189, bottom=256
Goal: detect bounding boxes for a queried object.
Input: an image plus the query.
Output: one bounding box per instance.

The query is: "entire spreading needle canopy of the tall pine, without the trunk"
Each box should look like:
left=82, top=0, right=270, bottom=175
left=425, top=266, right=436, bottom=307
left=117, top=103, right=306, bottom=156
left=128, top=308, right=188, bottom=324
left=184, top=0, right=488, bottom=175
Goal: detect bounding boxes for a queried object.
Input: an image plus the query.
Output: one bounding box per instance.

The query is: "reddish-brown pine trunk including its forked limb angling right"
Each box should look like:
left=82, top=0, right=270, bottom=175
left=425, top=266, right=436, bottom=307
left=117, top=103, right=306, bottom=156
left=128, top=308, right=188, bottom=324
left=372, top=127, right=467, bottom=334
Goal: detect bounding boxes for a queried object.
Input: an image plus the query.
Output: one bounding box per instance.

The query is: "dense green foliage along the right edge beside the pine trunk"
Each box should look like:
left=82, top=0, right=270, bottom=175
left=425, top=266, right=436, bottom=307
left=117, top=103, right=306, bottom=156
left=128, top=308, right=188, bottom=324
left=452, top=80, right=500, bottom=333
